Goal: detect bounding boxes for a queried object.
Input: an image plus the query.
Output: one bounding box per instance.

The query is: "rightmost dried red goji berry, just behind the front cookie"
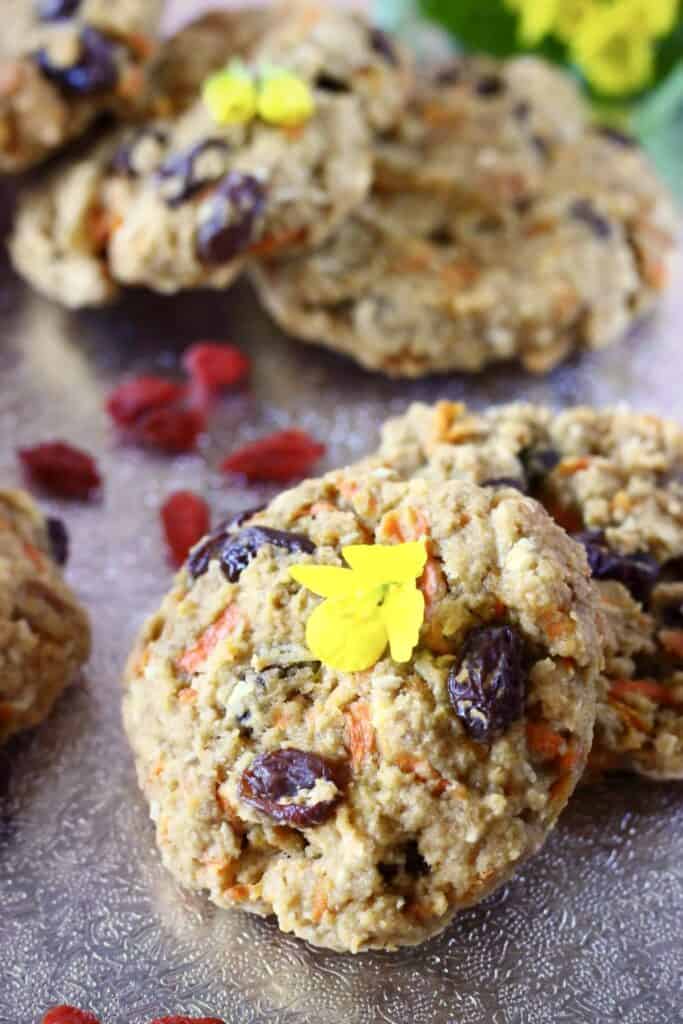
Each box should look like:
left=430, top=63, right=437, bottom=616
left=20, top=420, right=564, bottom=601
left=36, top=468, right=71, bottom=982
left=220, top=430, right=325, bottom=483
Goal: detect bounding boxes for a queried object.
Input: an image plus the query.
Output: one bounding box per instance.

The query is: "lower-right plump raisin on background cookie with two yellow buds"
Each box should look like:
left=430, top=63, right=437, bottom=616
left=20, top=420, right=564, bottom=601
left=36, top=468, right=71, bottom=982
left=197, top=171, right=265, bottom=266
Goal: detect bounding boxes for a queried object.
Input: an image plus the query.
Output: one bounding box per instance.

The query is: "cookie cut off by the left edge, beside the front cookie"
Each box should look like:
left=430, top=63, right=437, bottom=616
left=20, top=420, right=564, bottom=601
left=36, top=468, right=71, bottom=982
left=0, top=490, right=90, bottom=742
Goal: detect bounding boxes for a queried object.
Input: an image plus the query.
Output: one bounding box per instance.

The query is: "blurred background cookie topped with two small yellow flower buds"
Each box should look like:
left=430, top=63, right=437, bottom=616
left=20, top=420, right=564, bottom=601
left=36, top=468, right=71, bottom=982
left=11, top=7, right=380, bottom=306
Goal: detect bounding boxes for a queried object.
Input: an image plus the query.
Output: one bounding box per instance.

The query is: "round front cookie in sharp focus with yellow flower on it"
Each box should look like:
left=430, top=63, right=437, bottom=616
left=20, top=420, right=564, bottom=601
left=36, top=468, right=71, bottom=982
left=124, top=466, right=600, bottom=952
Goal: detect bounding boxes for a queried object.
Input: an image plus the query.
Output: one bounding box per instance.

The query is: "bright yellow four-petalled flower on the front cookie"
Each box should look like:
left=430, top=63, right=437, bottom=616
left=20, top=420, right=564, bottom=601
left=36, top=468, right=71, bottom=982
left=290, top=541, right=427, bottom=672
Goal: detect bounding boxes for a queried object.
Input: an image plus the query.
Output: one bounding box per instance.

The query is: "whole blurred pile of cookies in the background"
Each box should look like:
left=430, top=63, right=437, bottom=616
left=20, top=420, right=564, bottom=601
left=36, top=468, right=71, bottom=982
left=5, top=0, right=676, bottom=377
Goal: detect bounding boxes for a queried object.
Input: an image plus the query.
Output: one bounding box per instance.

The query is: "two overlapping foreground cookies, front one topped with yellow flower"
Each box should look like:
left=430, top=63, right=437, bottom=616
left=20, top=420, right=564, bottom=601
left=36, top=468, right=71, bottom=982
left=124, top=401, right=683, bottom=952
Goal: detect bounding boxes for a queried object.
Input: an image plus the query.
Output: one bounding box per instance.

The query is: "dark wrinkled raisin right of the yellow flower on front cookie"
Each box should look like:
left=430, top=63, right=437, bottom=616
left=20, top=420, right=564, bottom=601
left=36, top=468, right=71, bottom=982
left=449, top=626, right=526, bottom=742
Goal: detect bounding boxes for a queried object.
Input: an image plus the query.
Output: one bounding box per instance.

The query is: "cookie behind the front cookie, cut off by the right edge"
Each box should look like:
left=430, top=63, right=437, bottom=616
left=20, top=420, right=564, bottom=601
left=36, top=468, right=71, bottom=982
left=379, top=402, right=683, bottom=779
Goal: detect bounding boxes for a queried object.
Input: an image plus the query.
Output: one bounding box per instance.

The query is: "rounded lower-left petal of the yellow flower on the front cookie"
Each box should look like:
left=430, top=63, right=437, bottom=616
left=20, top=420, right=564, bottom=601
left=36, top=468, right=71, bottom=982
left=306, top=597, right=387, bottom=672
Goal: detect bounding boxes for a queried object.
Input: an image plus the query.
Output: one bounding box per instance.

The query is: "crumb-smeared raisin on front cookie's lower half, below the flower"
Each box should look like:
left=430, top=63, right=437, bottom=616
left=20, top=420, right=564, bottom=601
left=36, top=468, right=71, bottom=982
left=240, top=746, right=349, bottom=828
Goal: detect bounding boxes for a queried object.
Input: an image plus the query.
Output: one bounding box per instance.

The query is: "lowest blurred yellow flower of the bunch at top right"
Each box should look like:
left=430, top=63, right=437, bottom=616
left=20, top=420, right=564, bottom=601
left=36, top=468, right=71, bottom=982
left=570, top=3, right=654, bottom=95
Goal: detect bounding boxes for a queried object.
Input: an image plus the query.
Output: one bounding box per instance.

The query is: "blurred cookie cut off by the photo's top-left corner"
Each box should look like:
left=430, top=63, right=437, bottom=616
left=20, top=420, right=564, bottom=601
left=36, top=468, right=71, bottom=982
left=0, top=0, right=163, bottom=173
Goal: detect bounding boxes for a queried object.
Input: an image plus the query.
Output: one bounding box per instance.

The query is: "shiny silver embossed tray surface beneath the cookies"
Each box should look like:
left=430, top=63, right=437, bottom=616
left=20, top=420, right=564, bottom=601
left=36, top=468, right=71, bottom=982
left=0, top=174, right=683, bottom=1024
